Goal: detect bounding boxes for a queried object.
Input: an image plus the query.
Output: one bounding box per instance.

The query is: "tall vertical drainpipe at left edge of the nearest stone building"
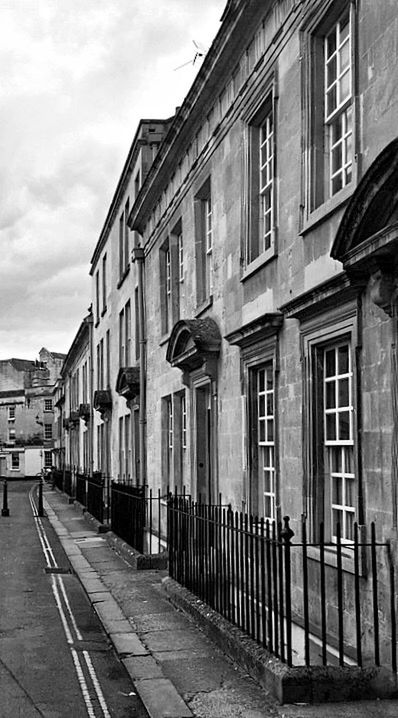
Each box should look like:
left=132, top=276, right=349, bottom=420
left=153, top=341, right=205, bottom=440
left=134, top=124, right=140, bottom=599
left=131, top=247, right=146, bottom=486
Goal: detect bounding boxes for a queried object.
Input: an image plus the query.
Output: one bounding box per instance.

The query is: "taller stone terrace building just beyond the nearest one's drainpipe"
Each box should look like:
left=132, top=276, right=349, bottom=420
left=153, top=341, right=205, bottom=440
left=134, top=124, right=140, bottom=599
left=90, top=119, right=170, bottom=496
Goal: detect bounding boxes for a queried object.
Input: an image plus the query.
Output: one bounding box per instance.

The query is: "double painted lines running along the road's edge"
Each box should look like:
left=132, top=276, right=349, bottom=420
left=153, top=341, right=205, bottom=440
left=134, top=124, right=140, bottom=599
left=29, top=487, right=111, bottom=718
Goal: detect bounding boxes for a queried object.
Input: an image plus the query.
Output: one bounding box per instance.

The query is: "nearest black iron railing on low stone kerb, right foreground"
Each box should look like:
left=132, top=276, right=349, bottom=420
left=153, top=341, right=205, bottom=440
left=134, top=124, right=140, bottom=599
left=168, top=496, right=397, bottom=671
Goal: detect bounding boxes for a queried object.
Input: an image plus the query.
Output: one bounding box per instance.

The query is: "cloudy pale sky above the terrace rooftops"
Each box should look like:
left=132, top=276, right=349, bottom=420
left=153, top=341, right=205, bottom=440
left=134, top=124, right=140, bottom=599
left=0, top=0, right=226, bottom=359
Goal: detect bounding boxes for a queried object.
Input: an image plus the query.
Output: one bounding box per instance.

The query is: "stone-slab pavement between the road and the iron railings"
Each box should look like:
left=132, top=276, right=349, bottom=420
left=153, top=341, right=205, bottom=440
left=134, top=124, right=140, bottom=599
left=44, top=486, right=398, bottom=718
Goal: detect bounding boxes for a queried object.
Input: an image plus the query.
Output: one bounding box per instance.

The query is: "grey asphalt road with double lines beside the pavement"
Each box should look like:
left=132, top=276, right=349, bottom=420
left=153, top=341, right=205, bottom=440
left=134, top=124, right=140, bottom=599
left=0, top=481, right=148, bottom=718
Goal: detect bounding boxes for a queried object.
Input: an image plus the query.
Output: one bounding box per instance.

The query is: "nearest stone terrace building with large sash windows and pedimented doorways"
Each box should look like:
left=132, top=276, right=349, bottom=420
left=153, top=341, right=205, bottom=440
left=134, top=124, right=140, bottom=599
left=129, top=0, right=398, bottom=664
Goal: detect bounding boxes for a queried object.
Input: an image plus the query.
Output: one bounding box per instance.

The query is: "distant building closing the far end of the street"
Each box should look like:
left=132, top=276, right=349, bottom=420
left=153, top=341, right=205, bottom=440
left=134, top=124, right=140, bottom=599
left=0, top=348, right=65, bottom=479
